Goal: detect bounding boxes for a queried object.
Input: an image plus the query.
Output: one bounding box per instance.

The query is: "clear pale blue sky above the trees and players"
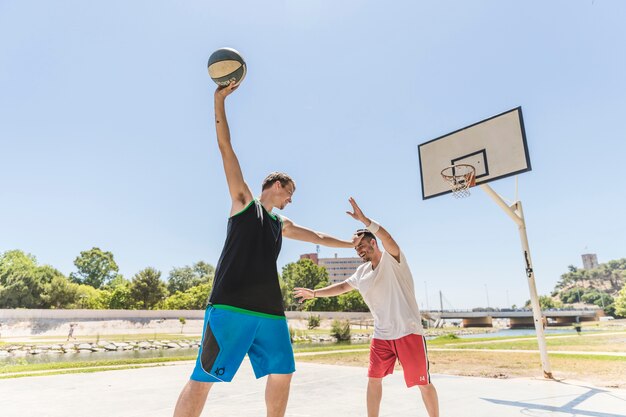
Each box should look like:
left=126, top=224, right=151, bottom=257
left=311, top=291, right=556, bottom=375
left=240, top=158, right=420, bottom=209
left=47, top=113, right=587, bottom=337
left=0, top=0, right=626, bottom=308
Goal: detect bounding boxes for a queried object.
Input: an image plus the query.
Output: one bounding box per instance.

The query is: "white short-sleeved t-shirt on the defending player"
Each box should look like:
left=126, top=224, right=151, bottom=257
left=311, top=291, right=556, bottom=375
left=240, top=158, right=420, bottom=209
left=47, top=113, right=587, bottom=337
left=345, top=251, right=424, bottom=340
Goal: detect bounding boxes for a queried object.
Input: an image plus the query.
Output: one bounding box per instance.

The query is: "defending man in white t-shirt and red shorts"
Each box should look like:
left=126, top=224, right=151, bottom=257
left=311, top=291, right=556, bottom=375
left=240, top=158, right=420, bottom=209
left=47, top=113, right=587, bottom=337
left=294, top=198, right=439, bottom=417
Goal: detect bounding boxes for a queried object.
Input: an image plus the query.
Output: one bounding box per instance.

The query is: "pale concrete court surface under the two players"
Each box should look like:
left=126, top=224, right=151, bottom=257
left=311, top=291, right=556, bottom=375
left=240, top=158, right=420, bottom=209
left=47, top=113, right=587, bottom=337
left=0, top=361, right=626, bottom=417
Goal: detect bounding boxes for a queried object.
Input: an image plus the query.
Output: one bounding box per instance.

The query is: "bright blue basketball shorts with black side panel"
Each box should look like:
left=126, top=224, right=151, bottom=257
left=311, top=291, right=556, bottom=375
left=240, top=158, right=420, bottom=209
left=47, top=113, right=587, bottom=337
left=191, top=305, right=296, bottom=382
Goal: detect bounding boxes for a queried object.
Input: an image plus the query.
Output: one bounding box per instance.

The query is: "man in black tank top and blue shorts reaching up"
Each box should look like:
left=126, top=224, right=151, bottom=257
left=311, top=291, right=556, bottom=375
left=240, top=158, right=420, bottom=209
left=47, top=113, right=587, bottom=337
left=174, top=83, right=354, bottom=417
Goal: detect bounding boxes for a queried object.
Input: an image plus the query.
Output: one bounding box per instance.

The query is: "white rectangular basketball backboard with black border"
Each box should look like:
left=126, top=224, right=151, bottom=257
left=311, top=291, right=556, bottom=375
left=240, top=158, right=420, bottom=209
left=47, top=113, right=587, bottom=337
left=418, top=107, right=531, bottom=200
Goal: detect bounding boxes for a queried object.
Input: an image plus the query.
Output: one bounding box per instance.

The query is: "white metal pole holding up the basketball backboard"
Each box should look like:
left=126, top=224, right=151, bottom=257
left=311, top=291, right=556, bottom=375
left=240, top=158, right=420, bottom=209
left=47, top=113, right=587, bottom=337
left=480, top=184, right=554, bottom=379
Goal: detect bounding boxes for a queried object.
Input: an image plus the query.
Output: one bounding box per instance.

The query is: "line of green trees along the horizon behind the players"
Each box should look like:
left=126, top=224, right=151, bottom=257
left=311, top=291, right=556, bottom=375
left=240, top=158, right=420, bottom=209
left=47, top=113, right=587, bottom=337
left=0, top=247, right=626, bottom=317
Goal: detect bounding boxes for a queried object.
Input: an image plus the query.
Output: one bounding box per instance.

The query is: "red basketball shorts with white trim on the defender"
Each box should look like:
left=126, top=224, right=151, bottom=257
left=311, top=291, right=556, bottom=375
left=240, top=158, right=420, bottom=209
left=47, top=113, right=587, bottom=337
left=367, top=334, right=430, bottom=387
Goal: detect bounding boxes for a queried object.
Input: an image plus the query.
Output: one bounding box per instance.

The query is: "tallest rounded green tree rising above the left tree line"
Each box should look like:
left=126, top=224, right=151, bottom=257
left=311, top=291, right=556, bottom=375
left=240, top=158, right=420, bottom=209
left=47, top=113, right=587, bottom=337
left=70, top=247, right=119, bottom=288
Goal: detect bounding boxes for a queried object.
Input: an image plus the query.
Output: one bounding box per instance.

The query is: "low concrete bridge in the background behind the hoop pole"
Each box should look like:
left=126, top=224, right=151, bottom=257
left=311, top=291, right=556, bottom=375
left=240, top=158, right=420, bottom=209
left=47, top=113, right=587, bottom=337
left=422, top=308, right=604, bottom=328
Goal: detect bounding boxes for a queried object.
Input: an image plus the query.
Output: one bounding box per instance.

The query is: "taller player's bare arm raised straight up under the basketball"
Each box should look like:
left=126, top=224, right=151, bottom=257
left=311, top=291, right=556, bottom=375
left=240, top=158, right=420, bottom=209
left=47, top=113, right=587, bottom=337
left=214, top=83, right=253, bottom=215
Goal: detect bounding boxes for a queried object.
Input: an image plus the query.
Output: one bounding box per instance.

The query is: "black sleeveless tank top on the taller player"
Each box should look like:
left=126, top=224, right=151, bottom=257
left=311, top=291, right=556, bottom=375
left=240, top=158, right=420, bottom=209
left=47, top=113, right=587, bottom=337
left=209, top=199, right=285, bottom=316
